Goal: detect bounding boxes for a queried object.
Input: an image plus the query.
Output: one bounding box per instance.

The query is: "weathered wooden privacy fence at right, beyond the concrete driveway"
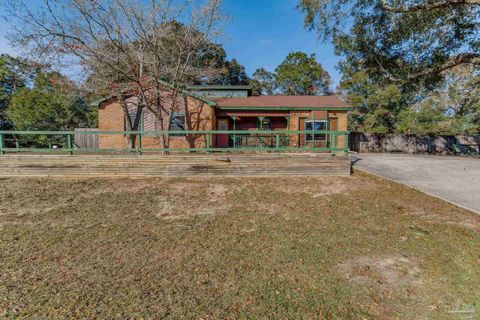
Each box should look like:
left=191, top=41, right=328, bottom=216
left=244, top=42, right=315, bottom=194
left=350, top=132, right=480, bottom=155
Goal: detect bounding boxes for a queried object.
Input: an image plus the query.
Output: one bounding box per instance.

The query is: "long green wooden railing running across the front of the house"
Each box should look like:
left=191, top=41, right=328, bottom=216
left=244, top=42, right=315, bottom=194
left=0, top=130, right=350, bottom=155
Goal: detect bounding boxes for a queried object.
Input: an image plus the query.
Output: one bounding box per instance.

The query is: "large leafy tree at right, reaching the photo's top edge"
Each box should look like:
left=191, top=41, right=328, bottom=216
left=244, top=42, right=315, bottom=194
left=299, top=0, right=480, bottom=134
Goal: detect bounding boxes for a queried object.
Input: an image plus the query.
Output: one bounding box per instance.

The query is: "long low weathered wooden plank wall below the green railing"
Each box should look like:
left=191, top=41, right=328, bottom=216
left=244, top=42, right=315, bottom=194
left=0, top=154, right=351, bottom=178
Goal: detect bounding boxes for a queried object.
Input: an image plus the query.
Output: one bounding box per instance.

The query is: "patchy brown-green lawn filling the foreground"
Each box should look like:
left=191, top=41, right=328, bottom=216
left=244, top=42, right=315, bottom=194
left=0, top=173, right=480, bottom=319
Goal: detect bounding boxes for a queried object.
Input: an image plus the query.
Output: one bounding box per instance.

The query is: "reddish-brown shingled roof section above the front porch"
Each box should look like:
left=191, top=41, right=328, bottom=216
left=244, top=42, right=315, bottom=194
left=212, top=96, right=353, bottom=110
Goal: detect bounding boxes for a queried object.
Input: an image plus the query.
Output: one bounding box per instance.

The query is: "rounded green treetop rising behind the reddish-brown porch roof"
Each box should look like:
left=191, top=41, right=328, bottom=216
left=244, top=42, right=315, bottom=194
left=275, top=52, right=331, bottom=96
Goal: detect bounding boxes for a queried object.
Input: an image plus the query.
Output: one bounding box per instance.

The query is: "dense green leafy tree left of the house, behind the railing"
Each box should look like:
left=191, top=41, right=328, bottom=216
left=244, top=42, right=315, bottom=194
left=6, top=72, right=95, bottom=131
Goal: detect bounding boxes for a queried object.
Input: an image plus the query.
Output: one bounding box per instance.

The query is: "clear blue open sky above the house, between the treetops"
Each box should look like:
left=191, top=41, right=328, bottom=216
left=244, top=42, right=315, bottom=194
left=0, top=0, right=340, bottom=85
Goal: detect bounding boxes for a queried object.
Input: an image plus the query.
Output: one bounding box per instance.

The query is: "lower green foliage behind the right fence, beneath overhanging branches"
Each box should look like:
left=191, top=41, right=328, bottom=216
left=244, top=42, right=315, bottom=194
left=338, top=62, right=480, bottom=134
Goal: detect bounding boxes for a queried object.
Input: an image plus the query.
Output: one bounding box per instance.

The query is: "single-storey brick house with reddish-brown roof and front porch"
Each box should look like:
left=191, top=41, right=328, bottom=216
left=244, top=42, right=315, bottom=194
left=96, top=86, right=352, bottom=150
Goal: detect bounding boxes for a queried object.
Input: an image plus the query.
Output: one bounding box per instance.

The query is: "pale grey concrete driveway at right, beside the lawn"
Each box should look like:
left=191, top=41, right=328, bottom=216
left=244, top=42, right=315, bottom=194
left=352, top=153, right=480, bottom=214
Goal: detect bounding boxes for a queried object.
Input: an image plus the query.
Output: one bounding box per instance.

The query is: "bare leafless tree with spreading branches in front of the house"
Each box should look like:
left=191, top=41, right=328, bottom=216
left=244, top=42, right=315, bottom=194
left=7, top=0, right=224, bottom=148
